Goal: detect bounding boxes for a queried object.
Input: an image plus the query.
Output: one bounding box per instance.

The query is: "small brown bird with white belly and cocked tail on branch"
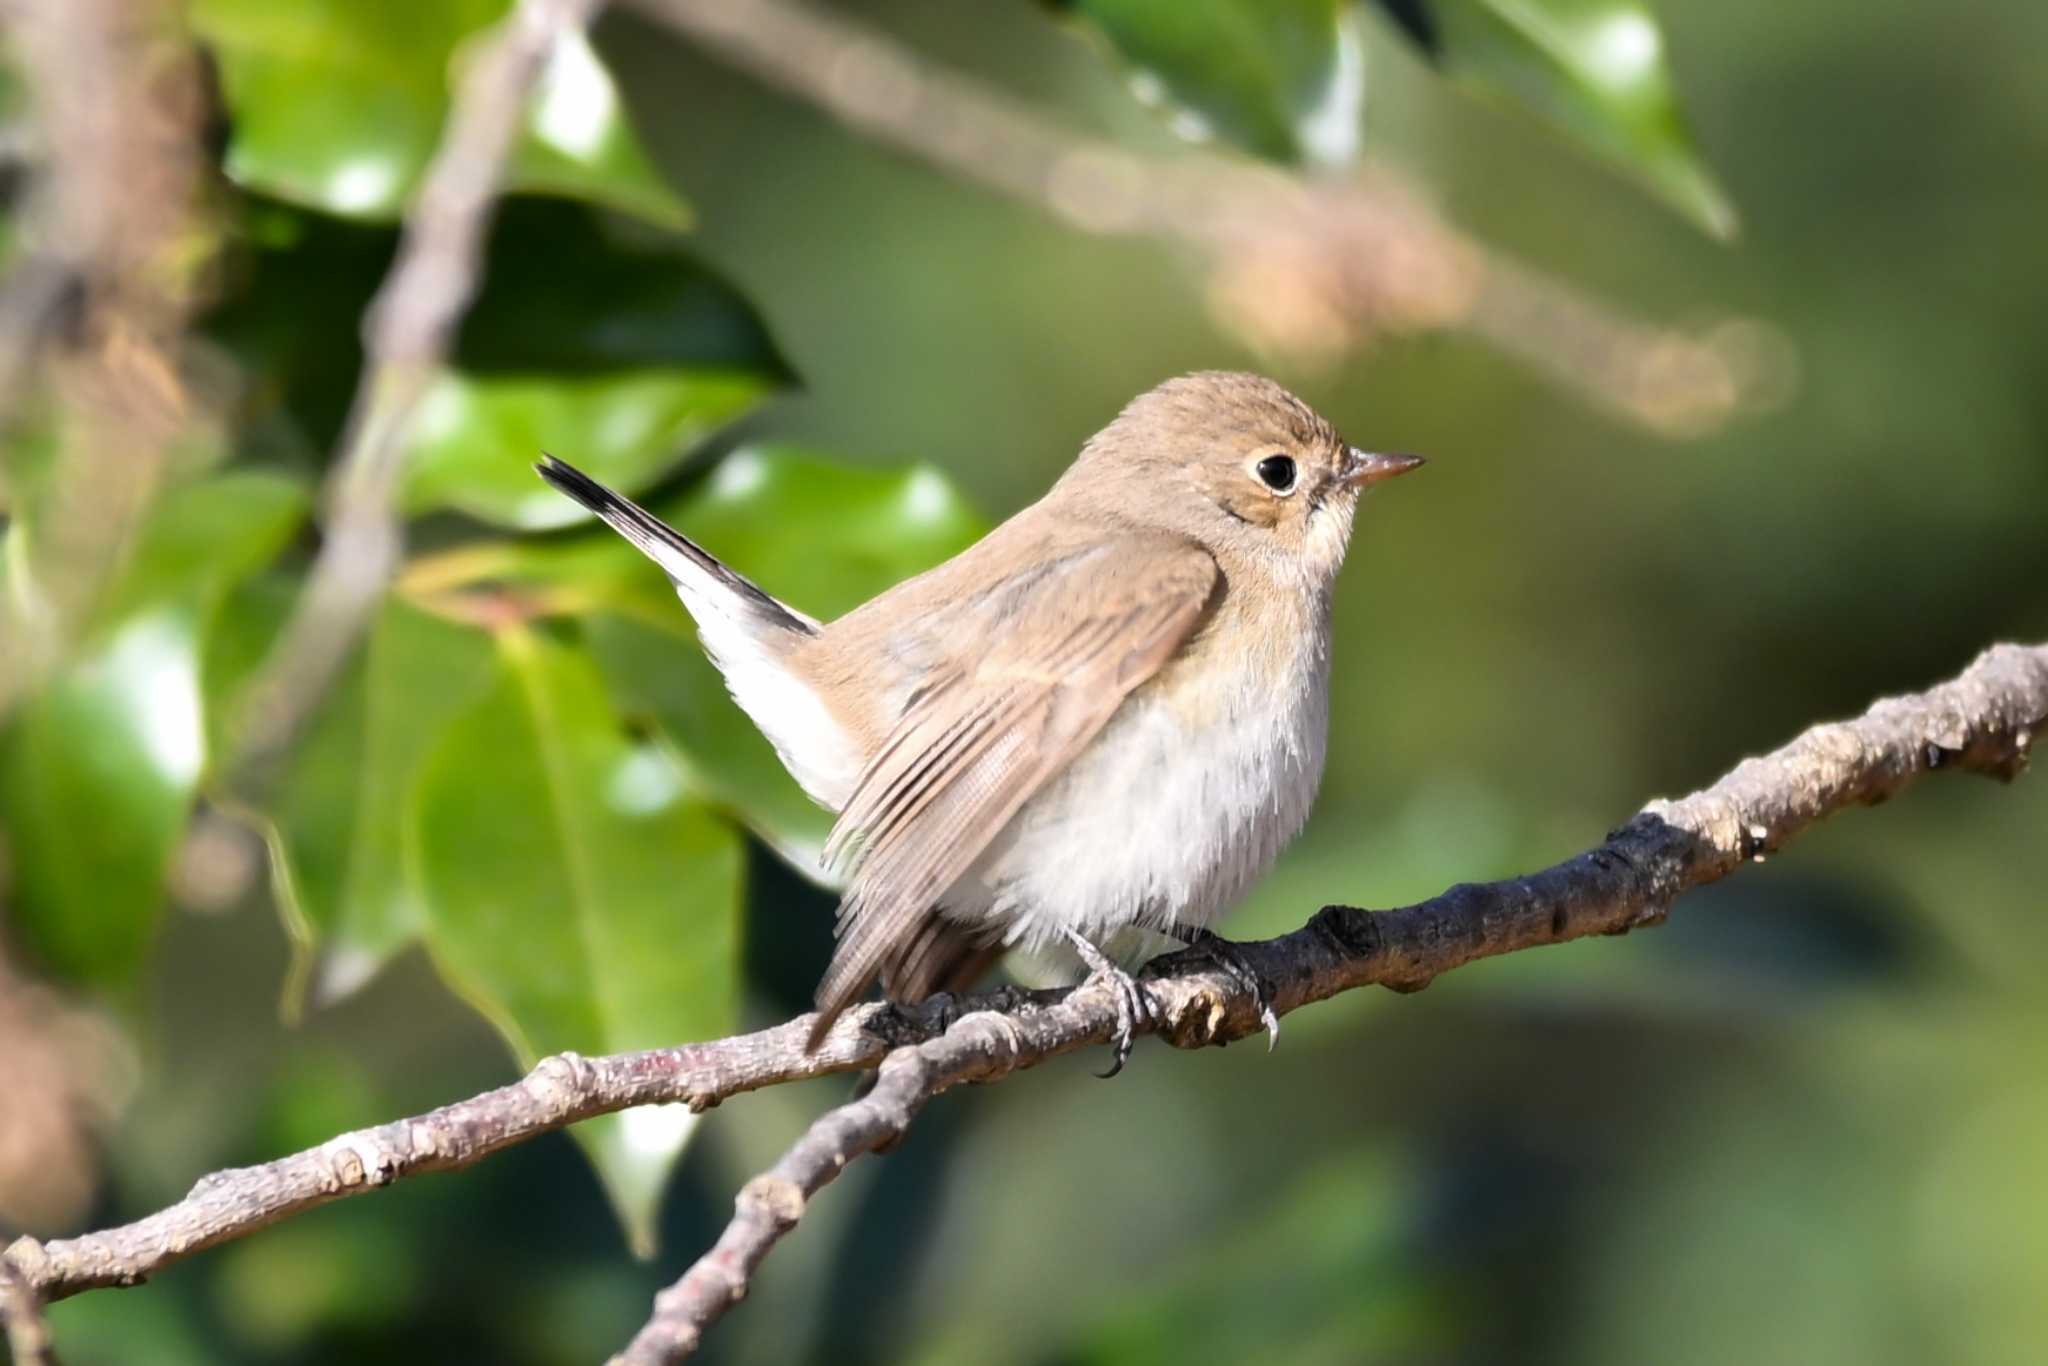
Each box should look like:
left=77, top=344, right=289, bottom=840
left=535, top=371, right=1421, bottom=1075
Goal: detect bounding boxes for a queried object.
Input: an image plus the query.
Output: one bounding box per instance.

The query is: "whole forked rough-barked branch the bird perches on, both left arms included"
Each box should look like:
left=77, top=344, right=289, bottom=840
left=0, top=645, right=2048, bottom=1366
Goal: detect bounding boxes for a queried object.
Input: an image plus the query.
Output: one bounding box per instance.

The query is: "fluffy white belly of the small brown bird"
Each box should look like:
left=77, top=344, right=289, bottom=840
left=942, top=633, right=1329, bottom=950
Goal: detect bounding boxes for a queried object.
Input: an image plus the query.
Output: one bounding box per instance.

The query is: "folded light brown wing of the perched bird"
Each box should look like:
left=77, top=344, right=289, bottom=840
left=817, top=532, right=1221, bottom=1034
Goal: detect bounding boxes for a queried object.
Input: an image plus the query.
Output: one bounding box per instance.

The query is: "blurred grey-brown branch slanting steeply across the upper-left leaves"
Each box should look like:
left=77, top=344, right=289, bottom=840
left=231, top=0, right=602, bottom=780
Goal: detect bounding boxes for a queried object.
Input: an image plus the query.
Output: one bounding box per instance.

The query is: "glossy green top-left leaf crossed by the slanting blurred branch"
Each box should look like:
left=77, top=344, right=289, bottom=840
left=193, top=0, right=688, bottom=227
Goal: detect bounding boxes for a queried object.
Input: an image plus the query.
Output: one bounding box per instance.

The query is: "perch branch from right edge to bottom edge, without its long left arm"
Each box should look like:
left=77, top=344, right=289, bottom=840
left=614, top=645, right=2048, bottom=1366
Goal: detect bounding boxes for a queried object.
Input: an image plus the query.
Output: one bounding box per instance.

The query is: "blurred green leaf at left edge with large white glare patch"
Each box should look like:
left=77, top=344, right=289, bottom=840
left=0, top=473, right=305, bottom=991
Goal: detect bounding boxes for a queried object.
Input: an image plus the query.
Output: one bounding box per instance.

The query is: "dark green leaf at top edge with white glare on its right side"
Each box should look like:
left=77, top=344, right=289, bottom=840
left=1059, top=0, right=1366, bottom=164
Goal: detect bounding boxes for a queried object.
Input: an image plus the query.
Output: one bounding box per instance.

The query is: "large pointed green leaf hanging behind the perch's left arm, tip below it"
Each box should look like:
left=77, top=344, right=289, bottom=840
left=410, top=629, right=743, bottom=1249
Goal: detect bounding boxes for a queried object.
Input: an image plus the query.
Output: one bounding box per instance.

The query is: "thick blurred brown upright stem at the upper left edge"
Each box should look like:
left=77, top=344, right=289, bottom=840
left=0, top=0, right=209, bottom=709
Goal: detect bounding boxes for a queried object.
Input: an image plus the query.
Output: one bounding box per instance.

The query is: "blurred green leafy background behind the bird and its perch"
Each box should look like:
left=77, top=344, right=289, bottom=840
left=0, top=0, right=2048, bottom=1366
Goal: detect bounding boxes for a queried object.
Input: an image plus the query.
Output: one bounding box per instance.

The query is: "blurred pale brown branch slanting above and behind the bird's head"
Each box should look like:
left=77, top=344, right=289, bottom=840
left=633, top=0, right=1782, bottom=434
